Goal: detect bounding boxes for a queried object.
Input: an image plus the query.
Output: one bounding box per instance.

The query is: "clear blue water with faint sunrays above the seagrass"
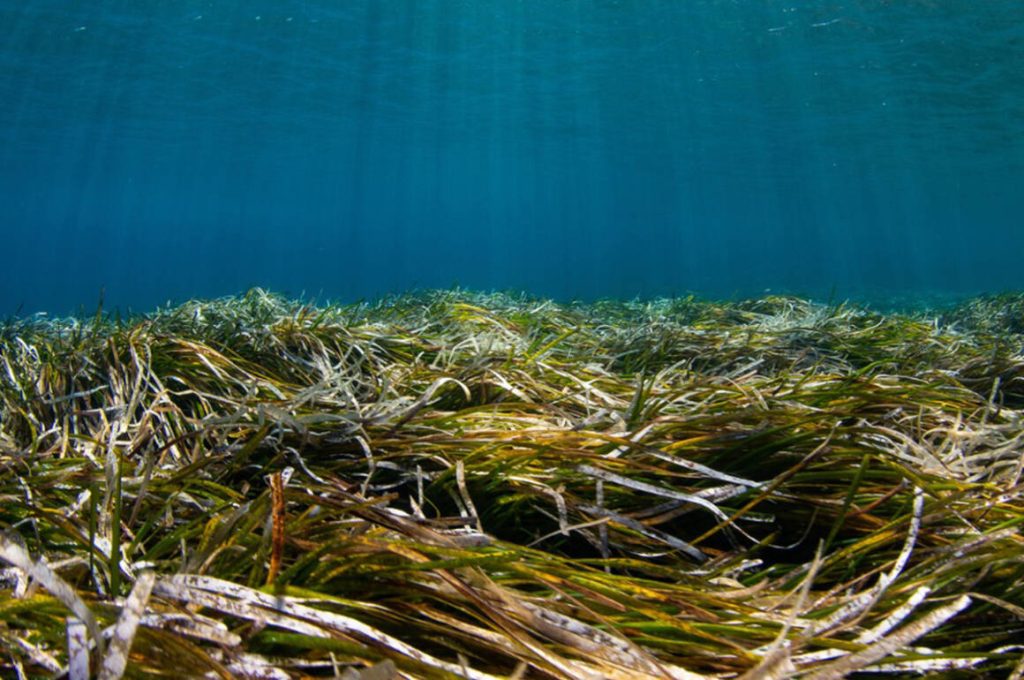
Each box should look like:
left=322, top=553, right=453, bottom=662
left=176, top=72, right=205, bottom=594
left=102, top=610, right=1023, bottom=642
left=0, top=0, right=1024, bottom=314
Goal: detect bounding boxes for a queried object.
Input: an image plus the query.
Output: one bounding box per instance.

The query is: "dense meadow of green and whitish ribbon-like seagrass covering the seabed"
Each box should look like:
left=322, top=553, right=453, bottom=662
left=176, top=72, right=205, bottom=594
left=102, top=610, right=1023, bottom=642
left=0, top=290, right=1024, bottom=680
